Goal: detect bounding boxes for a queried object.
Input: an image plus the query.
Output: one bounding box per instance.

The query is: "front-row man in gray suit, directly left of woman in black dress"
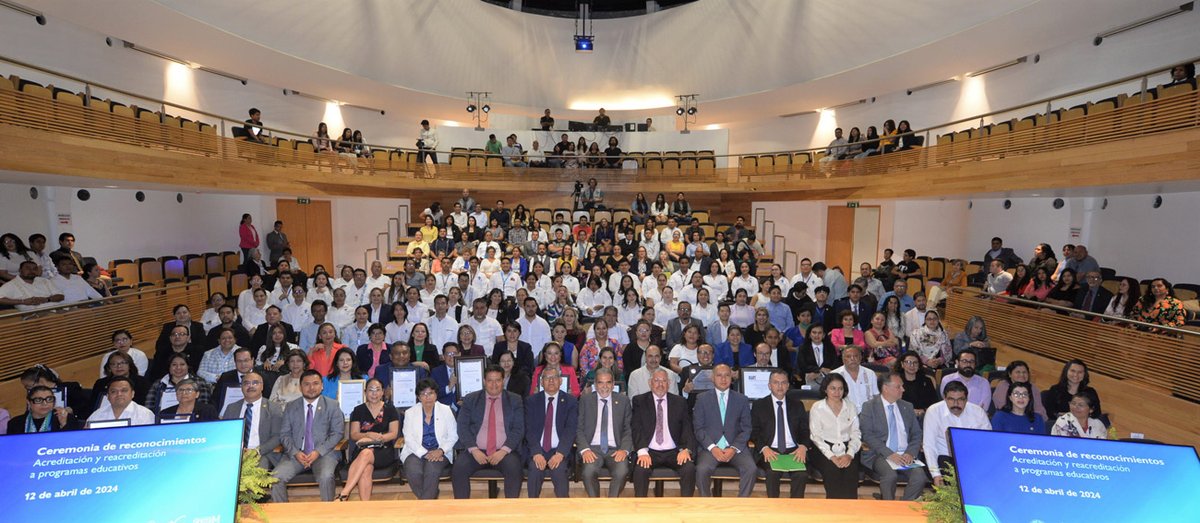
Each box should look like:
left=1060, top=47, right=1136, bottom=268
left=271, top=369, right=346, bottom=501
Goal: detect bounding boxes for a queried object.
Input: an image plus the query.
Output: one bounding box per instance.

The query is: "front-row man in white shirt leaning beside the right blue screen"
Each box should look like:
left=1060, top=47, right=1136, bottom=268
left=922, top=381, right=991, bottom=487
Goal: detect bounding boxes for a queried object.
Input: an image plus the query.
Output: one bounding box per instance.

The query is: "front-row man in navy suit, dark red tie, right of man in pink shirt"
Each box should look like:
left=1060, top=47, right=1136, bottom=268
left=522, top=367, right=580, bottom=498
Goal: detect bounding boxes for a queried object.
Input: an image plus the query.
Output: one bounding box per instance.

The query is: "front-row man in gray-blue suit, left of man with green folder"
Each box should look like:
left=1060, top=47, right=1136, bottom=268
left=692, top=363, right=758, bottom=498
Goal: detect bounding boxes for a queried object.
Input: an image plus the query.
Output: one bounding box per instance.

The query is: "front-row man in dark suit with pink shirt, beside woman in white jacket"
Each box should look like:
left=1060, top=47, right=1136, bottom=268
left=451, top=365, right=524, bottom=499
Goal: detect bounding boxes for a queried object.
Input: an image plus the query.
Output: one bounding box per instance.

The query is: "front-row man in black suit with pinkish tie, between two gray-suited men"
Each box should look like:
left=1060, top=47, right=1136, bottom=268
left=631, top=368, right=696, bottom=498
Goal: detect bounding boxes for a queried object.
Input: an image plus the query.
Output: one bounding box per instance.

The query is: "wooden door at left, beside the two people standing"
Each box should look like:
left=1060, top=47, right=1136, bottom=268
left=275, top=199, right=334, bottom=272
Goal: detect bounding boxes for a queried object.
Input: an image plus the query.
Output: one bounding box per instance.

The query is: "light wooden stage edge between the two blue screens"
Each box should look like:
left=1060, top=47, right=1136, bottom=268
left=264, top=497, right=925, bottom=523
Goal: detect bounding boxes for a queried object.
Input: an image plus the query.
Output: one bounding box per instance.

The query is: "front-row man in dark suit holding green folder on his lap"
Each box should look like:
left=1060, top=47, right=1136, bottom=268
left=750, top=369, right=809, bottom=498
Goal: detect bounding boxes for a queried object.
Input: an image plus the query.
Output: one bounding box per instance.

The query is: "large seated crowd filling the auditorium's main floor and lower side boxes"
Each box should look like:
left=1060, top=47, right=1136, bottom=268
left=7, top=196, right=1177, bottom=501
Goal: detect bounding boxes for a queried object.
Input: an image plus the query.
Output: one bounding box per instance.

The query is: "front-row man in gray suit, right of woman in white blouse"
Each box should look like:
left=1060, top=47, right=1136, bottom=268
left=858, top=372, right=926, bottom=501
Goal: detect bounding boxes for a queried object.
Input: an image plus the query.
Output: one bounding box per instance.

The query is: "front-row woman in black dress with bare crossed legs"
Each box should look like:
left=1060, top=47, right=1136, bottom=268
left=337, top=378, right=400, bottom=501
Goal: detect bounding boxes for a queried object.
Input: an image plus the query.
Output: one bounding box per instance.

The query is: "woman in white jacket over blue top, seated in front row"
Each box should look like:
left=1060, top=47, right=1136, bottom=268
left=400, top=379, right=458, bottom=499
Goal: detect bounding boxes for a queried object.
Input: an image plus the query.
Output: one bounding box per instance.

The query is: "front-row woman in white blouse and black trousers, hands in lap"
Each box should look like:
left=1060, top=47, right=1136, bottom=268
left=809, top=373, right=862, bottom=499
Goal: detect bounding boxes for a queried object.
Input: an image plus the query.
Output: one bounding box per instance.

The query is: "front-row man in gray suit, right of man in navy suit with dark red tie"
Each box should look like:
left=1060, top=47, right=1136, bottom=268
left=575, top=367, right=634, bottom=498
